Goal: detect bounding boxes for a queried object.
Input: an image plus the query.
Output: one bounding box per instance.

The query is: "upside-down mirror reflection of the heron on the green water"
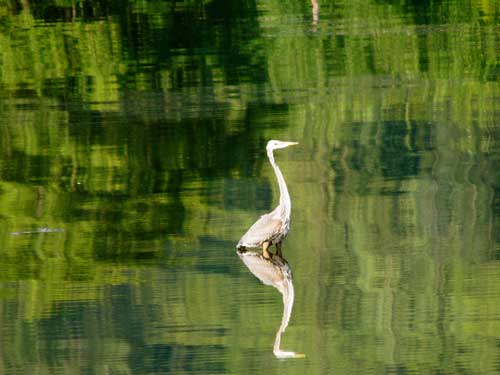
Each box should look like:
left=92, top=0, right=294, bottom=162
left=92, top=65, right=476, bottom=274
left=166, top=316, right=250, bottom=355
left=238, top=249, right=305, bottom=358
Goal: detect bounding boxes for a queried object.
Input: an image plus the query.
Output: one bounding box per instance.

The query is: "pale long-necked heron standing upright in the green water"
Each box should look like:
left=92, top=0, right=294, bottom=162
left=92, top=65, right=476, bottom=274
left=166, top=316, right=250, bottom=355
left=236, top=140, right=298, bottom=259
